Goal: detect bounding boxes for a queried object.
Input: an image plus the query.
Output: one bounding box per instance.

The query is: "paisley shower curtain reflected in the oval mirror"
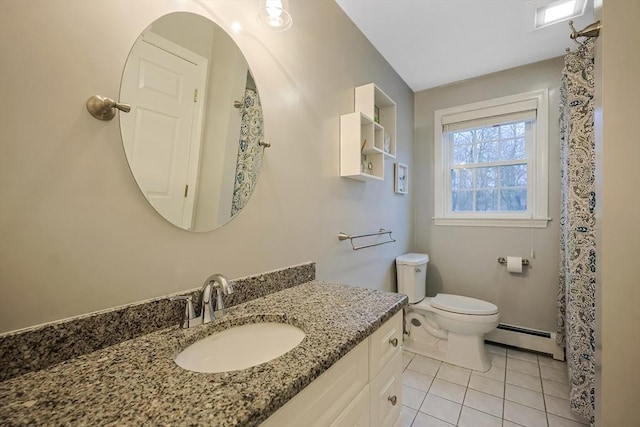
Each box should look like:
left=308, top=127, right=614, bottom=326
left=231, top=89, right=264, bottom=216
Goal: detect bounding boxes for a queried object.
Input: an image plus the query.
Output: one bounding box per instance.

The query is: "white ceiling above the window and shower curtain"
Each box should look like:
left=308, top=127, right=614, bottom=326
left=335, top=0, right=593, bottom=92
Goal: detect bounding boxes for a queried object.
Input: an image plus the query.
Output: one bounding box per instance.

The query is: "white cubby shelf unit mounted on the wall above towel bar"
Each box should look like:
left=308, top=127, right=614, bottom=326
left=340, top=83, right=396, bottom=181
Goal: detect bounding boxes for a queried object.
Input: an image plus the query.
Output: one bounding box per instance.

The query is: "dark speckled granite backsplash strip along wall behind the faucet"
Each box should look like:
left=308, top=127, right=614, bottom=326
left=0, top=262, right=316, bottom=381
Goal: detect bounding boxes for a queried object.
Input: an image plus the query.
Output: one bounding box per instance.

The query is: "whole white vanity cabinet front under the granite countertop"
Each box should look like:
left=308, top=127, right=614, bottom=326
left=262, top=311, right=402, bottom=427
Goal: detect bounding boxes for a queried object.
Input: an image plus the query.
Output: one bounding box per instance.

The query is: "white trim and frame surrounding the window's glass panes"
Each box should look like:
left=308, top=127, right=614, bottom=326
left=433, top=89, right=551, bottom=228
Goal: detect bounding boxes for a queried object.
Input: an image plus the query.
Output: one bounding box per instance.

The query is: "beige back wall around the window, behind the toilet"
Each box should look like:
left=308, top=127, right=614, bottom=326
left=413, top=58, right=569, bottom=332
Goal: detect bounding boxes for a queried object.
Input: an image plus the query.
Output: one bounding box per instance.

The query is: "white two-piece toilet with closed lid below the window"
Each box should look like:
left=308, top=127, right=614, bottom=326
left=396, top=253, right=499, bottom=372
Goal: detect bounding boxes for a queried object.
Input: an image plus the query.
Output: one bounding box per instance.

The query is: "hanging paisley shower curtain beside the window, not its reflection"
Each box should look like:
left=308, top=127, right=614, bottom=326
left=557, top=39, right=596, bottom=425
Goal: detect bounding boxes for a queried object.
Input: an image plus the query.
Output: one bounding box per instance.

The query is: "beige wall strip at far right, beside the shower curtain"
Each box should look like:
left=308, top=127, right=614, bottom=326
left=596, top=0, right=640, bottom=427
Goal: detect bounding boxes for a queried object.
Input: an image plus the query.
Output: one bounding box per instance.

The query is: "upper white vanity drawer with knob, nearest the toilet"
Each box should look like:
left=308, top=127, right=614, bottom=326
left=369, top=310, right=402, bottom=378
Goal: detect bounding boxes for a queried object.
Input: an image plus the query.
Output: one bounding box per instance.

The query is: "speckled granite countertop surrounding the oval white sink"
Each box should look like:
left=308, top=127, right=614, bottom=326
left=0, top=281, right=407, bottom=426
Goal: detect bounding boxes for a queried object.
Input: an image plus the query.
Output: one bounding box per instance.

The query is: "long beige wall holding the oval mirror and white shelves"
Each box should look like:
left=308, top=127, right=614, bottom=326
left=0, top=0, right=413, bottom=331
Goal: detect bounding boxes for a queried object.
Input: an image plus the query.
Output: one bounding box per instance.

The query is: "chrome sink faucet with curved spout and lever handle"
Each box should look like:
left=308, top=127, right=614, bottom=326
left=169, top=274, right=233, bottom=329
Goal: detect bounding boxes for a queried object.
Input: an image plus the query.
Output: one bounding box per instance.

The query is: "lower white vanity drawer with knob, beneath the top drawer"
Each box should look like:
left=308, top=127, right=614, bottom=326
left=370, top=352, right=402, bottom=427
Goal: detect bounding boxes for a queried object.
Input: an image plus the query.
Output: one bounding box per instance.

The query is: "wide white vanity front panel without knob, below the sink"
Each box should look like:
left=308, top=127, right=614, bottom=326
left=261, top=340, right=369, bottom=427
